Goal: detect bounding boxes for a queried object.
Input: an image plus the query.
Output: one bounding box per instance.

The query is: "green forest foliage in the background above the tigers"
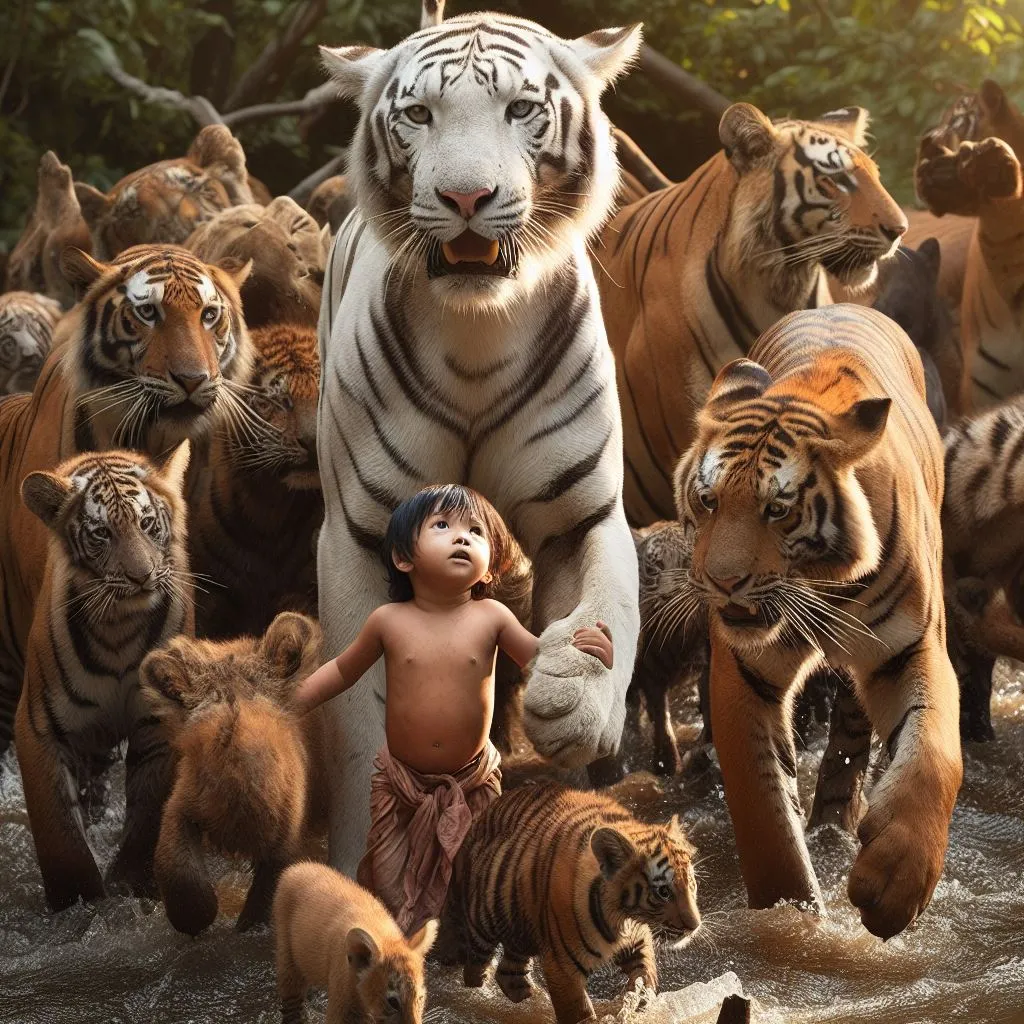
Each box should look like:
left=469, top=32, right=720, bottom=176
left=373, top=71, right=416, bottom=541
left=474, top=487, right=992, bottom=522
left=0, top=0, right=1024, bottom=246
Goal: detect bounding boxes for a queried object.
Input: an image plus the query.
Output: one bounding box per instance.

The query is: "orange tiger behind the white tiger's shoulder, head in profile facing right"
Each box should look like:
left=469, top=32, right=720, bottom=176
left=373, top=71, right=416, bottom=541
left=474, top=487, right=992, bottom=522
left=593, top=103, right=907, bottom=525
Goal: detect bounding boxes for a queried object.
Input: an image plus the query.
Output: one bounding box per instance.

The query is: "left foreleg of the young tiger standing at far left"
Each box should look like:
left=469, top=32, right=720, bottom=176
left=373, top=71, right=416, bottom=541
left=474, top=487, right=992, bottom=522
left=14, top=684, right=105, bottom=910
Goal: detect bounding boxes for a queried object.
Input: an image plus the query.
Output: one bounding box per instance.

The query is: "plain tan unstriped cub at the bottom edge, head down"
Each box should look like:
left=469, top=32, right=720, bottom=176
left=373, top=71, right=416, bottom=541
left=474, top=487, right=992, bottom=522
left=273, top=862, right=437, bottom=1024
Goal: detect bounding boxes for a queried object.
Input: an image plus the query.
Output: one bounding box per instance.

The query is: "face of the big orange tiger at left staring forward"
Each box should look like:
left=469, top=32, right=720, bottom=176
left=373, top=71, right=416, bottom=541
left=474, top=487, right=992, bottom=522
left=62, top=246, right=252, bottom=450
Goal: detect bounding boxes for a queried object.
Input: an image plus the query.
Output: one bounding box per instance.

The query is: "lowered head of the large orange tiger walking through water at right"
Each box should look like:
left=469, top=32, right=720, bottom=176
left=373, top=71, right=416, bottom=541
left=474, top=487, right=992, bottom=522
left=676, top=359, right=890, bottom=649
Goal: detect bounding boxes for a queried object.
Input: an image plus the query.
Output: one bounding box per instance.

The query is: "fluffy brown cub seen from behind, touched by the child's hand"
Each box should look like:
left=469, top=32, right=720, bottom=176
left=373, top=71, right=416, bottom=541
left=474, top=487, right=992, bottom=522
left=141, top=612, right=327, bottom=935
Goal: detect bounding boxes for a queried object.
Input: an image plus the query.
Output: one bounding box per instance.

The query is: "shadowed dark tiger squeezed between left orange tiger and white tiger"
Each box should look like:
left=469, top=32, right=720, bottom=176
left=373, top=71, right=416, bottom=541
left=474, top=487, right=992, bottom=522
left=189, top=325, right=324, bottom=639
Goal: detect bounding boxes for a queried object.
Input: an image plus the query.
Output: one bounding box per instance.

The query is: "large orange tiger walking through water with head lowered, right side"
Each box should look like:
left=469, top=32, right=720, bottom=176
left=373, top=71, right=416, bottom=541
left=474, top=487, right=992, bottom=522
left=675, top=304, right=963, bottom=938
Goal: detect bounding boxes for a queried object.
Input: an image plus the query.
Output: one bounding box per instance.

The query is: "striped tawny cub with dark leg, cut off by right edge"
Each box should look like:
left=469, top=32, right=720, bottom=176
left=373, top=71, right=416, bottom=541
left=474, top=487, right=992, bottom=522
left=942, top=397, right=1024, bottom=741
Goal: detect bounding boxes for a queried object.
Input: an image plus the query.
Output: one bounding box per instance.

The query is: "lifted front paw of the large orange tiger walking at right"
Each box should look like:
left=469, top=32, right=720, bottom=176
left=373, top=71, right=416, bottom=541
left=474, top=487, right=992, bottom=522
left=848, top=807, right=945, bottom=939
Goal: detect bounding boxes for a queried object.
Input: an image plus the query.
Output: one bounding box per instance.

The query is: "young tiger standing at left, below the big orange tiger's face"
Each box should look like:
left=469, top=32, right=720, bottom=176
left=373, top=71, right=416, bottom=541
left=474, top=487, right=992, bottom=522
left=14, top=441, right=193, bottom=910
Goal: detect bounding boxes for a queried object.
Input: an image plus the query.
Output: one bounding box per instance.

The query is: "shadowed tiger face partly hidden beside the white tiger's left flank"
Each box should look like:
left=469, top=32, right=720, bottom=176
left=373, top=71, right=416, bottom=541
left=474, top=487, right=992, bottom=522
left=237, top=325, right=321, bottom=490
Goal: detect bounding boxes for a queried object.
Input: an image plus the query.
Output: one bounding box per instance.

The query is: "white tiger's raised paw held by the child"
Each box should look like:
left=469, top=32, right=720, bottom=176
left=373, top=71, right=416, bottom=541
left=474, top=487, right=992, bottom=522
left=523, top=621, right=625, bottom=768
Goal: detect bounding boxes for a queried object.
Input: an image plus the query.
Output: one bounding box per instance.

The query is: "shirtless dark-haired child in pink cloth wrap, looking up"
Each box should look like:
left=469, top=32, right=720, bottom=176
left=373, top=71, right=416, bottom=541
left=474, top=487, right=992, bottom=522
left=296, top=484, right=612, bottom=935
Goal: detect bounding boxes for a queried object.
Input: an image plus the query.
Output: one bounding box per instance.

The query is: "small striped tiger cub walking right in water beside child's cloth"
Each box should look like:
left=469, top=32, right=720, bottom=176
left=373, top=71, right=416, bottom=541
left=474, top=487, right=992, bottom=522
left=446, top=783, right=700, bottom=1024
